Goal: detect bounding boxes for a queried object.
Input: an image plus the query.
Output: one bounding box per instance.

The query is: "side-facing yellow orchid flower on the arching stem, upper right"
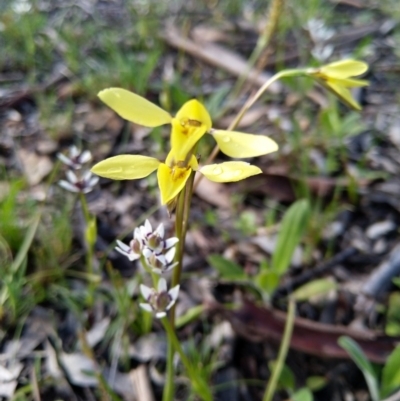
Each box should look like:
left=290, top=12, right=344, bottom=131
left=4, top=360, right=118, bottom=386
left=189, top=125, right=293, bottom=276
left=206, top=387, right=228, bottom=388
left=307, top=60, right=368, bottom=110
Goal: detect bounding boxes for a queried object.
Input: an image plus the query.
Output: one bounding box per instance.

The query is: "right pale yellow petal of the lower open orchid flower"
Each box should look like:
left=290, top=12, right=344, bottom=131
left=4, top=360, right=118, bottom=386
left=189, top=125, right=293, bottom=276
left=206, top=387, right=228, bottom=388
left=199, top=162, right=262, bottom=182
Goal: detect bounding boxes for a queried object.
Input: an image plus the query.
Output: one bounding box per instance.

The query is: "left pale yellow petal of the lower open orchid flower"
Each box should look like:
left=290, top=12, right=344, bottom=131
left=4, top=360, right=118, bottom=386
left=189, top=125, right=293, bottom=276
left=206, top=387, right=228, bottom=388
left=91, top=155, right=160, bottom=180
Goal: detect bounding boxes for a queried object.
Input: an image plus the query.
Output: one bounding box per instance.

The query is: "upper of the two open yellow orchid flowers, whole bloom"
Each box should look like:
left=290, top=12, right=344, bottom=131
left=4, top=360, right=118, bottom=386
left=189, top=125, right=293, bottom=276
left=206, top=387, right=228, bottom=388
left=99, top=88, right=278, bottom=160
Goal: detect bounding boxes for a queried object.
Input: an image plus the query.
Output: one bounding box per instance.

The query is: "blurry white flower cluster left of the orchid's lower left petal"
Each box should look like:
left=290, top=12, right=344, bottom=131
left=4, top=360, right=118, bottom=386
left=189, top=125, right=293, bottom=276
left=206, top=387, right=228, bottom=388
left=57, top=146, right=99, bottom=194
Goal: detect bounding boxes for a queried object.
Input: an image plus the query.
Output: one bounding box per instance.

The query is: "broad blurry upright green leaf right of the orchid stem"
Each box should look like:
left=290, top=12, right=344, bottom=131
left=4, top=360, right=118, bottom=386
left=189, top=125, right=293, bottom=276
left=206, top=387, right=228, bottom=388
left=272, top=199, right=310, bottom=275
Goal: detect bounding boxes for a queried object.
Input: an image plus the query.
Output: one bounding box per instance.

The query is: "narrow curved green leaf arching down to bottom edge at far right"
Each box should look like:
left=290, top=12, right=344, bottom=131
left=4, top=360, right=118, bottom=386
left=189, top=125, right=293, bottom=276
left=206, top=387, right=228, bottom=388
left=338, top=336, right=379, bottom=401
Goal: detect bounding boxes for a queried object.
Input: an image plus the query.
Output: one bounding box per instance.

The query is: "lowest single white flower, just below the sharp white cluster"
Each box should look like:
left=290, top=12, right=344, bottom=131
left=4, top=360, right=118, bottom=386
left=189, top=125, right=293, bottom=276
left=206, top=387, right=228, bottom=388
left=139, top=278, right=179, bottom=319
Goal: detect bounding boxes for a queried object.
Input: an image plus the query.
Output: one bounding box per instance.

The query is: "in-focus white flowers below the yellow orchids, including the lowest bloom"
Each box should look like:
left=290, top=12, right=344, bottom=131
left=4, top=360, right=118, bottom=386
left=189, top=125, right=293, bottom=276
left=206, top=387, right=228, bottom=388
left=115, top=220, right=179, bottom=318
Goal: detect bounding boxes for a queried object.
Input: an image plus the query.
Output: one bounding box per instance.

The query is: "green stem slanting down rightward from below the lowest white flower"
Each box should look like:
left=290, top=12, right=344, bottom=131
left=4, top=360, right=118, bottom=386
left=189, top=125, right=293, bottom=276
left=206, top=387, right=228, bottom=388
left=161, top=317, right=213, bottom=401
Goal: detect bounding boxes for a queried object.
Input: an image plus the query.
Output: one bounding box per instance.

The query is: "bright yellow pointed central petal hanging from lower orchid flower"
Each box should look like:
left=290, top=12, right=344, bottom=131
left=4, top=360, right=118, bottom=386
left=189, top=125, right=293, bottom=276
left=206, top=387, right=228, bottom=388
left=157, top=163, right=192, bottom=205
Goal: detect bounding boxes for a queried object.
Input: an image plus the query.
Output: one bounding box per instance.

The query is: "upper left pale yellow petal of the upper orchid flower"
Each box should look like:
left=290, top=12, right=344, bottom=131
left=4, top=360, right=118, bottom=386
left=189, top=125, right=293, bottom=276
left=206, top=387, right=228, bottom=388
left=98, top=88, right=171, bottom=127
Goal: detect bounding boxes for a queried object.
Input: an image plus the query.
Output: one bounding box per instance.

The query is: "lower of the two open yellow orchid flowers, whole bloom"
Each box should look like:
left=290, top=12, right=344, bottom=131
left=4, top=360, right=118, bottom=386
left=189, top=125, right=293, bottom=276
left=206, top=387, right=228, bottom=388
left=91, top=149, right=261, bottom=205
